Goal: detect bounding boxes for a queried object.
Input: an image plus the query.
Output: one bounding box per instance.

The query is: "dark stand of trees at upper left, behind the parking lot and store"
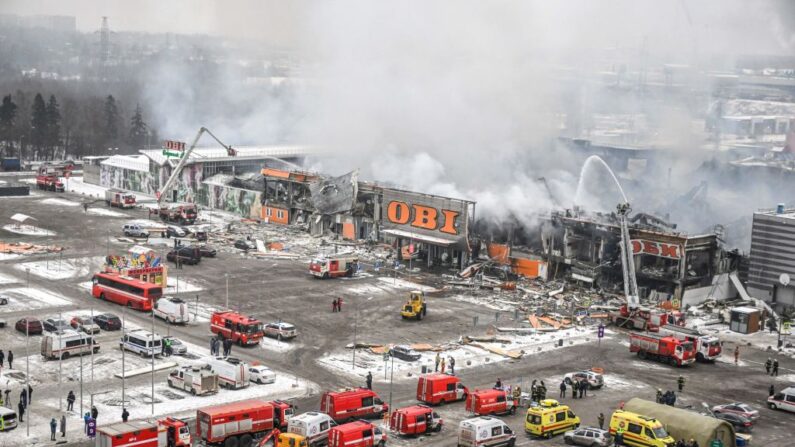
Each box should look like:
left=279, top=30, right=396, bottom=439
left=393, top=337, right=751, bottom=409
left=0, top=90, right=158, bottom=160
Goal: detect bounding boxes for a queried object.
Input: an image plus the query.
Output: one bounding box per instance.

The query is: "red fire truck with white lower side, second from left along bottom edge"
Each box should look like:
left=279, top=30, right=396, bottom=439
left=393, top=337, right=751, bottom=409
left=196, top=399, right=294, bottom=446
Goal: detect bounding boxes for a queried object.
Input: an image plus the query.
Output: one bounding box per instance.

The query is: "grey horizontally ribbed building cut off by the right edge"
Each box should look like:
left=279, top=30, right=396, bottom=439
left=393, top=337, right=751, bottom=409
left=748, top=205, right=795, bottom=310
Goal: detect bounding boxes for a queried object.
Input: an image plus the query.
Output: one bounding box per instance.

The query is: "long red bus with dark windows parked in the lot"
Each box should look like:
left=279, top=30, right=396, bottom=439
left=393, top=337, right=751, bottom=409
left=91, top=272, right=163, bottom=312
